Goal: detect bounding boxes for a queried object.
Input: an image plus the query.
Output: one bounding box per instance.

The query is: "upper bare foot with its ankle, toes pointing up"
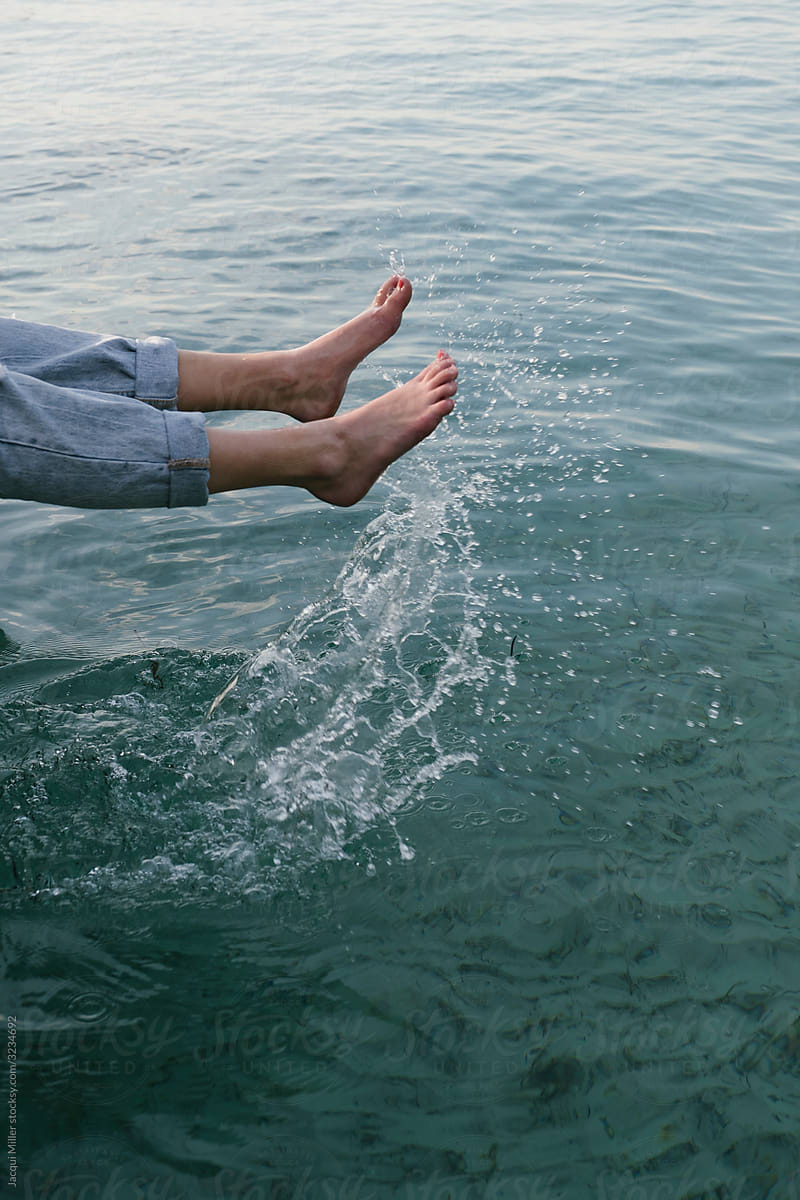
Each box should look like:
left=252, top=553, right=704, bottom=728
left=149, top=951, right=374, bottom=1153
left=235, top=275, right=411, bottom=421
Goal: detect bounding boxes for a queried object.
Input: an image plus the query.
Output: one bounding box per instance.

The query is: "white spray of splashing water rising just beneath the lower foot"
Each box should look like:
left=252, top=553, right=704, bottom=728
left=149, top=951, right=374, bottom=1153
left=206, top=472, right=491, bottom=878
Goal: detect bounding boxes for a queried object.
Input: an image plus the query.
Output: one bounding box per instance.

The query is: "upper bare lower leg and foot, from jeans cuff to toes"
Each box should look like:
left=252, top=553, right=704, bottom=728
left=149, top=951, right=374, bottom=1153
left=178, top=275, right=411, bottom=421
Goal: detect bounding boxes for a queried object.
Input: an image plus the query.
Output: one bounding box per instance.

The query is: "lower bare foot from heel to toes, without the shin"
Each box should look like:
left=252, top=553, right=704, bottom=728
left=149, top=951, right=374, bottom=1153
left=305, top=350, right=458, bottom=506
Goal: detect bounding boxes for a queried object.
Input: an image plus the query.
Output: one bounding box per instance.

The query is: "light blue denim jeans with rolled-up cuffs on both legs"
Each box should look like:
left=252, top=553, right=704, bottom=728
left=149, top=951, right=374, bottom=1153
left=0, top=318, right=209, bottom=509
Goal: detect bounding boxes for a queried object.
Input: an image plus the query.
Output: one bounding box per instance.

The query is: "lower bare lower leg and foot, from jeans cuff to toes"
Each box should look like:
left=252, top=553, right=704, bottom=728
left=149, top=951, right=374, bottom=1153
left=207, top=352, right=458, bottom=506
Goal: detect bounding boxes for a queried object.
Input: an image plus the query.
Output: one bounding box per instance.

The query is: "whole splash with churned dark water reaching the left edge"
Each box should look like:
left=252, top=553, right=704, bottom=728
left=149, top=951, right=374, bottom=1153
left=4, top=468, right=492, bottom=904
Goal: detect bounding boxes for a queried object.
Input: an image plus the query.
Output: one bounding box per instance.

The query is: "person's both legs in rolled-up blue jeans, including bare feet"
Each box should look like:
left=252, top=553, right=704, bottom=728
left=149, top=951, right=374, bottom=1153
left=0, top=284, right=450, bottom=508
